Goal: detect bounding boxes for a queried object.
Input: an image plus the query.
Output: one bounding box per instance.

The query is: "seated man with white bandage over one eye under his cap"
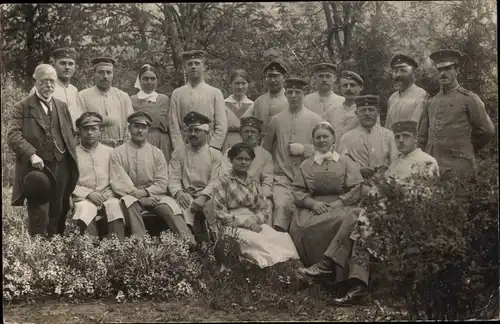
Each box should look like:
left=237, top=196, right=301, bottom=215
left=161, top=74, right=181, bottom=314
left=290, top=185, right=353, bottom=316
left=168, top=111, right=222, bottom=235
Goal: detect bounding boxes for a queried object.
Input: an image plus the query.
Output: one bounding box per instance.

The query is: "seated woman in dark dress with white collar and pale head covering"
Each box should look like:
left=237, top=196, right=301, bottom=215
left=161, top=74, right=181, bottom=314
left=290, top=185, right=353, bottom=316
left=290, top=121, right=368, bottom=305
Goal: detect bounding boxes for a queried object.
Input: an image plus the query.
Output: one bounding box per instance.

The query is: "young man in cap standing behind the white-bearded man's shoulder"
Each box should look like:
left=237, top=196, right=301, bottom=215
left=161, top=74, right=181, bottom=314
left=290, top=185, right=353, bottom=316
left=30, top=47, right=85, bottom=129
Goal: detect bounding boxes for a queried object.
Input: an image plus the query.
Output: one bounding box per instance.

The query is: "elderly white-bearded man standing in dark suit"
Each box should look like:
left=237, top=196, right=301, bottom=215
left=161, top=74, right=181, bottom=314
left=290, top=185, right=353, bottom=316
left=7, top=64, right=79, bottom=237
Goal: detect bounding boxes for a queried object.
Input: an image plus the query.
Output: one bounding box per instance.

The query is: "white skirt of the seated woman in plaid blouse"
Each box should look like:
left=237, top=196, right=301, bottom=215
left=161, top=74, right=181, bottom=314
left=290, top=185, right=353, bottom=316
left=228, top=224, right=299, bottom=268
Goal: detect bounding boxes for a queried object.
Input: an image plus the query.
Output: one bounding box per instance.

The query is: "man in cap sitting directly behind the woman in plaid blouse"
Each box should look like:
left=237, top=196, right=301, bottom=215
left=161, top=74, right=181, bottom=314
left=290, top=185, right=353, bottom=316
left=220, top=117, right=274, bottom=226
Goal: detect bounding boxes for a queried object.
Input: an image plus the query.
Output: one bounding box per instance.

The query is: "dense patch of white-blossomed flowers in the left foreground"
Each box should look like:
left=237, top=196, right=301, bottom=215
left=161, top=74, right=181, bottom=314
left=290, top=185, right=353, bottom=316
left=2, top=190, right=201, bottom=301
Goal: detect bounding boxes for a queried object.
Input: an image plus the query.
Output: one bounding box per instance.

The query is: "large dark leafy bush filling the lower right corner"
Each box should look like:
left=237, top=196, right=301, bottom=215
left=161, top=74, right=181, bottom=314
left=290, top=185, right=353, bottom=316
left=362, top=157, right=499, bottom=320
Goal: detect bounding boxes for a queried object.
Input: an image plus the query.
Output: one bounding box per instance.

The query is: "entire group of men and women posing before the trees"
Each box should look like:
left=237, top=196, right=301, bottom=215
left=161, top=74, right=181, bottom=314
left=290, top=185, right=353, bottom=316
left=7, top=48, right=495, bottom=305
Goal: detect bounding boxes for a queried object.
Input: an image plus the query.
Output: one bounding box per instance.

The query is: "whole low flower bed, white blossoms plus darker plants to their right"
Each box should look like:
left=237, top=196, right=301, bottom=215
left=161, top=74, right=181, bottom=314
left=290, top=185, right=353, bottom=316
left=2, top=189, right=331, bottom=318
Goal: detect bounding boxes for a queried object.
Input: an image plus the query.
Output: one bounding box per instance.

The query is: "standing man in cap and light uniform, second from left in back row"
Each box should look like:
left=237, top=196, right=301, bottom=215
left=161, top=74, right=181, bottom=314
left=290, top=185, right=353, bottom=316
left=80, top=57, right=134, bottom=148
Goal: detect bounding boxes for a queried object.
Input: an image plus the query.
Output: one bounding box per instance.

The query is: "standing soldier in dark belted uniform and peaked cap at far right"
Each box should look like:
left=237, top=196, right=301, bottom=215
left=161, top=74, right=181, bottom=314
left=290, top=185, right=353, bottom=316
left=419, top=49, right=495, bottom=177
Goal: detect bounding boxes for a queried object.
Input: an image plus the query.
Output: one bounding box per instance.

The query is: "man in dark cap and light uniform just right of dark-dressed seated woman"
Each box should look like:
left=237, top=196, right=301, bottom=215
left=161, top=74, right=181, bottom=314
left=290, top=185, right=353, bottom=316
left=338, top=95, right=398, bottom=189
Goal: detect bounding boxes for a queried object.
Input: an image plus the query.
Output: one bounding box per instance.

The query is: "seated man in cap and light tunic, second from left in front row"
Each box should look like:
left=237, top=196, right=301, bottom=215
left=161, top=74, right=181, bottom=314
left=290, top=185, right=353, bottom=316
left=110, top=111, right=196, bottom=248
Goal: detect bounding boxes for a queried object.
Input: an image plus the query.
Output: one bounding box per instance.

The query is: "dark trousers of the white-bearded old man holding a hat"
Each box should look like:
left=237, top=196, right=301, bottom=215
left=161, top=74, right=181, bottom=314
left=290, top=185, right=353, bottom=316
left=28, top=153, right=71, bottom=237
